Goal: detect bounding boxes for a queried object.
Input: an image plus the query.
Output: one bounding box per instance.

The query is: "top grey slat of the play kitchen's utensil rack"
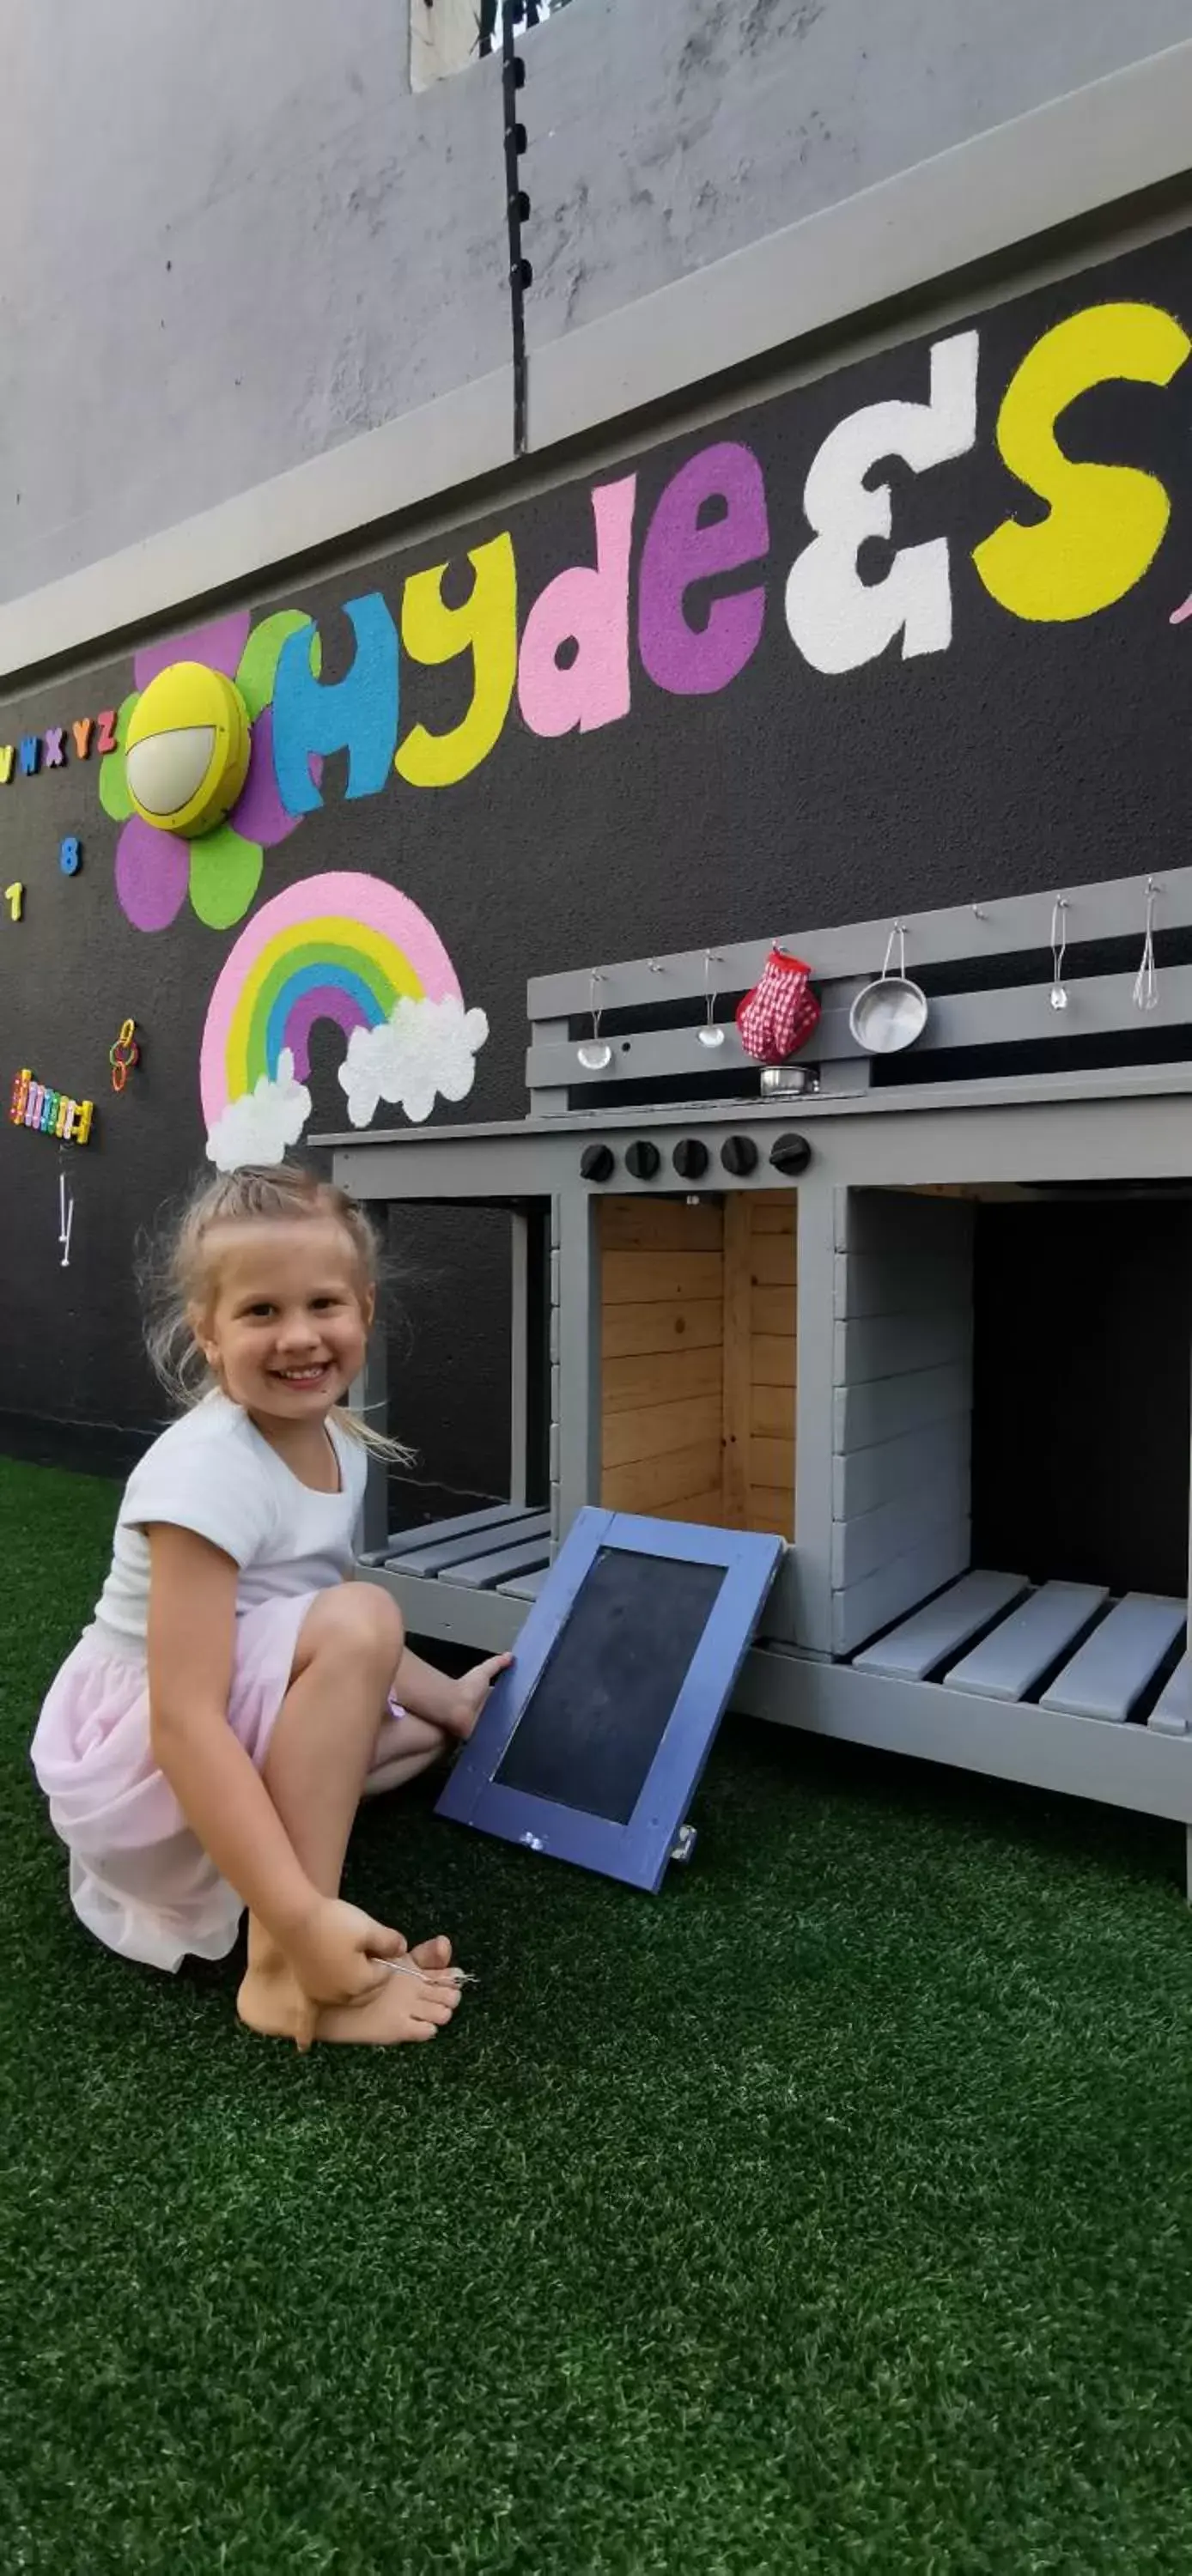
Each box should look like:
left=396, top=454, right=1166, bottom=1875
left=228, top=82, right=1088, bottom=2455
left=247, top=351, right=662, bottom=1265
left=528, top=868, right=1192, bottom=1020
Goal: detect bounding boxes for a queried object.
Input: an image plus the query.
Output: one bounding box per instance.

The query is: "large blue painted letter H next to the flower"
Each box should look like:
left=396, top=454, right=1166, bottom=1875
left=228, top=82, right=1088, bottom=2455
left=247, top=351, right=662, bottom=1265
left=273, top=590, right=397, bottom=814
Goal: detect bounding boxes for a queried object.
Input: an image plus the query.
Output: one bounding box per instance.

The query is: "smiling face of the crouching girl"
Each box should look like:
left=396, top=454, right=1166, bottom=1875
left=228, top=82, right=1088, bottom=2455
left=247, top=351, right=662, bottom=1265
left=191, top=1216, right=374, bottom=1422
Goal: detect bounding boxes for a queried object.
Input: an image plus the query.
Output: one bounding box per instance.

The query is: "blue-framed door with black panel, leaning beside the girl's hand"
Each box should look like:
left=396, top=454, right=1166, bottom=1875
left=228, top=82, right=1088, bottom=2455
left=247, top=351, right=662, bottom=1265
left=435, top=1507, right=785, bottom=1891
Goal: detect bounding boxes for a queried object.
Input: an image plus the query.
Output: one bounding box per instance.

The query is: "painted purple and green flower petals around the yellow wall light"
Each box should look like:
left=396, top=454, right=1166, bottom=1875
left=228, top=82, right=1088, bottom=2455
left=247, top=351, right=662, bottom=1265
left=100, top=608, right=317, bottom=930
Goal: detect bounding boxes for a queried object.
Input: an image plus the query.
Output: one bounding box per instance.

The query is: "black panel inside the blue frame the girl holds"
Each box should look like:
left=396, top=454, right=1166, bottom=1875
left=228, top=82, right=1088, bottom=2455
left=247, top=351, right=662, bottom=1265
left=495, top=1548, right=726, bottom=1824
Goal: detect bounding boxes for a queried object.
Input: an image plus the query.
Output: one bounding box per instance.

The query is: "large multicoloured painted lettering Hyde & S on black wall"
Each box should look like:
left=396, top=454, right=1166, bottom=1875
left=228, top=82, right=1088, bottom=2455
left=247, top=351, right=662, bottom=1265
left=249, top=304, right=1192, bottom=814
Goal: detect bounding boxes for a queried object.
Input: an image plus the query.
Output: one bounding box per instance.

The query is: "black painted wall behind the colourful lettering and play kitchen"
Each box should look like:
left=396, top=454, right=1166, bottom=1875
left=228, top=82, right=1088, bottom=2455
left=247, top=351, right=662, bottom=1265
left=0, top=237, right=1192, bottom=1489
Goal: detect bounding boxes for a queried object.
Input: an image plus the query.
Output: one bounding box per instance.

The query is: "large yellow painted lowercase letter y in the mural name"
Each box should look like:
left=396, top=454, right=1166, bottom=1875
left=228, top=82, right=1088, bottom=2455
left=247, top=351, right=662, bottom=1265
left=394, top=536, right=518, bottom=788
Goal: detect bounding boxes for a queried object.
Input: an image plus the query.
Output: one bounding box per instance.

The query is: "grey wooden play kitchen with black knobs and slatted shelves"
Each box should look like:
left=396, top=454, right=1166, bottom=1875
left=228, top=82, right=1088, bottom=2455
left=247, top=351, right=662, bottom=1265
left=322, top=871, right=1192, bottom=1891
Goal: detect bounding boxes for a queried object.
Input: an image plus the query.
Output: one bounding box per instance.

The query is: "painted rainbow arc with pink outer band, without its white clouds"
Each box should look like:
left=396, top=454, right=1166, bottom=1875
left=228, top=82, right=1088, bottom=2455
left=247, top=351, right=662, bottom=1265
left=198, top=871, right=464, bottom=1133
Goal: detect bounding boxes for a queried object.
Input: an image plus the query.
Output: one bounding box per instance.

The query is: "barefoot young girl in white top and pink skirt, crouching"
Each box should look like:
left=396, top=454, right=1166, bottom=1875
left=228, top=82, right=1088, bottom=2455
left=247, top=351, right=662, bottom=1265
left=33, top=1164, right=510, bottom=2048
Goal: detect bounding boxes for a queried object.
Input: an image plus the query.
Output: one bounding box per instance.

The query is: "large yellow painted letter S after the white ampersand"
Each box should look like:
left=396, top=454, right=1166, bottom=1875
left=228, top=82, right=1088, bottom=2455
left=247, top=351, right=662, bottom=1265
left=973, top=304, right=1192, bottom=623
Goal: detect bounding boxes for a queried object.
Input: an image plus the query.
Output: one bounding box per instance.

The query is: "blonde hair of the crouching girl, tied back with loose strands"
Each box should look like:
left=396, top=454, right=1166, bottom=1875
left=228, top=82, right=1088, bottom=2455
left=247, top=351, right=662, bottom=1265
left=139, top=1162, right=415, bottom=1466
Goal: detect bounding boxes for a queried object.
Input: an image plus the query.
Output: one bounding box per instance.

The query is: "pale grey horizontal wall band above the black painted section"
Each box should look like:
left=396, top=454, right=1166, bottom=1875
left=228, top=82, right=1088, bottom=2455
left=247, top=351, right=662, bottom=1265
left=0, top=41, right=1192, bottom=680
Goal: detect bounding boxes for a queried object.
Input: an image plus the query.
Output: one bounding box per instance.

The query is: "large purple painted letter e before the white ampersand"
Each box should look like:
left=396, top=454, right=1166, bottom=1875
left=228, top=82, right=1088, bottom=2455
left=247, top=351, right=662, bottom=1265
left=638, top=440, right=769, bottom=698
